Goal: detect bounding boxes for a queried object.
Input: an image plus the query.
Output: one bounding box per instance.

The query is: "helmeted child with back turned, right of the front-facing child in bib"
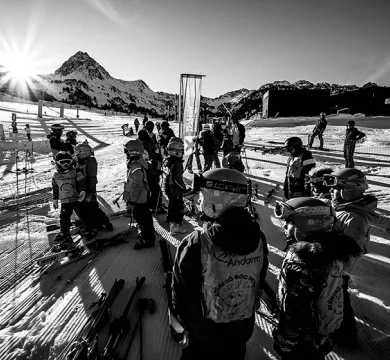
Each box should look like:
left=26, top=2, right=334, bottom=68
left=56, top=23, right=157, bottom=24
left=74, top=143, right=114, bottom=237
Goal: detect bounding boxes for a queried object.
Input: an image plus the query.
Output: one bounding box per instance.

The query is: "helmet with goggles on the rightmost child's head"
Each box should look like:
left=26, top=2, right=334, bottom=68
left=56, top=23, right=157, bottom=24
left=324, top=169, right=368, bottom=201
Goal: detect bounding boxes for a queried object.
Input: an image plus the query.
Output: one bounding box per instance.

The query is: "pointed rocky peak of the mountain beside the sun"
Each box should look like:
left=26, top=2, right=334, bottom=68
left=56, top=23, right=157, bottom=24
left=54, top=51, right=111, bottom=80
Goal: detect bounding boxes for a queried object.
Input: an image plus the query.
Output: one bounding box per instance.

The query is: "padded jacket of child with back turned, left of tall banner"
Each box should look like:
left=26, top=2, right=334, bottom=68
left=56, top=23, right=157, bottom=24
left=123, top=158, right=149, bottom=204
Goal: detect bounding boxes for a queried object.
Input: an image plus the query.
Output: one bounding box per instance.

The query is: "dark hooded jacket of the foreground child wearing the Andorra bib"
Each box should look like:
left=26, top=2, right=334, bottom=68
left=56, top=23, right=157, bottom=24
left=172, top=208, right=268, bottom=348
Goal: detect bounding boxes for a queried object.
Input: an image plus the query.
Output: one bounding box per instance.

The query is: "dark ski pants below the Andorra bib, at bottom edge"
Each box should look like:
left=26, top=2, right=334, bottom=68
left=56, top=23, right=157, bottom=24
left=180, top=333, right=246, bottom=360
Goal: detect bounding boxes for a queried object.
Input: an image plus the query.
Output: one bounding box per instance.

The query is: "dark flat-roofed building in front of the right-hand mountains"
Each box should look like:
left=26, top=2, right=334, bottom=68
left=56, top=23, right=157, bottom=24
left=263, top=89, right=330, bottom=118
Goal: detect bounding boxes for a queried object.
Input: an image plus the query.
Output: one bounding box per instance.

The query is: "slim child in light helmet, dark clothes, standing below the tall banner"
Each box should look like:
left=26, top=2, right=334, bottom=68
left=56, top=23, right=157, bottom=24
left=165, top=137, right=187, bottom=235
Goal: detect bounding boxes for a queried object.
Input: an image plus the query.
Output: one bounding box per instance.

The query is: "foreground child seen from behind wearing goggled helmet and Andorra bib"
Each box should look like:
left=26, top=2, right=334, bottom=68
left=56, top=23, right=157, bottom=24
left=172, top=169, right=268, bottom=360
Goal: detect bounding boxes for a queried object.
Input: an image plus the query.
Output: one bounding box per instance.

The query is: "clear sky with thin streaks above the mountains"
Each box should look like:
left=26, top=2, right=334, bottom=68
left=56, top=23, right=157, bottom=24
left=0, top=0, right=390, bottom=97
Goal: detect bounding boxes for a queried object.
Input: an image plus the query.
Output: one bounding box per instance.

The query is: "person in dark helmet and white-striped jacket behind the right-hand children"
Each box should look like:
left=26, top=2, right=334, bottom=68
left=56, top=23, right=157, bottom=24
left=283, top=136, right=316, bottom=199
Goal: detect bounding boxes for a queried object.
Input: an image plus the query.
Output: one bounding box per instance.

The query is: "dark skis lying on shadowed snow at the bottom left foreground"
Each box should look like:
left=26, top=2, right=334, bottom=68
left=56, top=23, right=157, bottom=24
left=66, top=277, right=145, bottom=360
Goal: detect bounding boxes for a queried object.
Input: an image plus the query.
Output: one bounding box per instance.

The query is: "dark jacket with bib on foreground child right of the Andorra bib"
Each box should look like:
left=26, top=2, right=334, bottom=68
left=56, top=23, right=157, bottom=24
left=273, top=232, right=360, bottom=359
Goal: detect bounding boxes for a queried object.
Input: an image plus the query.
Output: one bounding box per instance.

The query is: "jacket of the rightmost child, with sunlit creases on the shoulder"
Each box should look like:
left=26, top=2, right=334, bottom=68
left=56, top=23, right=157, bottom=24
left=332, top=195, right=380, bottom=272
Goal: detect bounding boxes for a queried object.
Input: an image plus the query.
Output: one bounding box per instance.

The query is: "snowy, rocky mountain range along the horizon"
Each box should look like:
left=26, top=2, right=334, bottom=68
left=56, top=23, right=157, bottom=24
left=0, top=51, right=386, bottom=118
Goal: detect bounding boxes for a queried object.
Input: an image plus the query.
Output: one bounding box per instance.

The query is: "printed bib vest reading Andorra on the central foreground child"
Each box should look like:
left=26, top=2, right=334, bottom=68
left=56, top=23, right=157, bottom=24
left=200, top=234, right=264, bottom=323
